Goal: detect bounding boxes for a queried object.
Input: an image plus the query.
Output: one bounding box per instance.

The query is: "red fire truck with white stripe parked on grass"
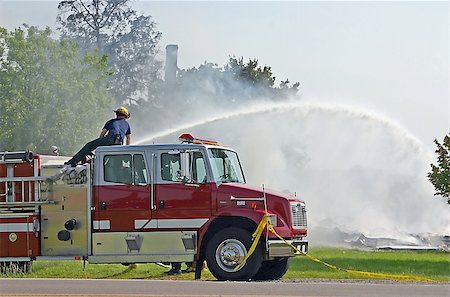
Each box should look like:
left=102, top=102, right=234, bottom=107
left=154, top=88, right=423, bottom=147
left=0, top=134, right=308, bottom=280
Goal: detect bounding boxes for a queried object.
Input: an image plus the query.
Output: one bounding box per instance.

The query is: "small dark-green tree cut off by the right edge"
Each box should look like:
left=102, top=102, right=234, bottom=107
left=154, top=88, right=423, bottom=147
left=428, top=134, right=450, bottom=204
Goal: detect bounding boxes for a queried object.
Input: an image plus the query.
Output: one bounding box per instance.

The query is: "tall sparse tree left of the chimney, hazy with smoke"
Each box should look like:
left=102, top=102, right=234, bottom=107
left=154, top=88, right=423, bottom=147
left=57, top=0, right=161, bottom=104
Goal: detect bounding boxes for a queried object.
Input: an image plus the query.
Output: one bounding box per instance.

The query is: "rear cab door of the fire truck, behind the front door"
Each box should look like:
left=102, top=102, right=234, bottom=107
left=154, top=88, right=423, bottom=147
left=93, top=152, right=152, bottom=232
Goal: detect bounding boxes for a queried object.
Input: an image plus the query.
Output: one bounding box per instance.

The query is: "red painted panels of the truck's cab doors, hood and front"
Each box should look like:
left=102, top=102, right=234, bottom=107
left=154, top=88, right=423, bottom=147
left=93, top=178, right=306, bottom=238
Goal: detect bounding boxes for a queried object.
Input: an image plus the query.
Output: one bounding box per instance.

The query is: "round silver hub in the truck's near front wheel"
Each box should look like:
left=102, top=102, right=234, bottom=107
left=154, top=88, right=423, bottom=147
left=216, top=239, right=247, bottom=272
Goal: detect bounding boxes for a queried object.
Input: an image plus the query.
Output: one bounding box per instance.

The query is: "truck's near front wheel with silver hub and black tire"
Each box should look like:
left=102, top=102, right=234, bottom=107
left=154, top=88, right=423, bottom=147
left=206, top=227, right=262, bottom=280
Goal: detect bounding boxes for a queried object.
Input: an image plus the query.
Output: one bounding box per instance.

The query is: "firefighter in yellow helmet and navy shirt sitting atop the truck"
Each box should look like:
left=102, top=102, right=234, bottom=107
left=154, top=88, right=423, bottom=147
left=64, top=106, right=131, bottom=167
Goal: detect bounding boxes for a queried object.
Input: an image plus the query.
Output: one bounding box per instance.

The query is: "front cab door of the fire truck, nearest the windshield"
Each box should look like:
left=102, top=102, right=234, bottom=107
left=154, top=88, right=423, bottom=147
left=155, top=150, right=212, bottom=230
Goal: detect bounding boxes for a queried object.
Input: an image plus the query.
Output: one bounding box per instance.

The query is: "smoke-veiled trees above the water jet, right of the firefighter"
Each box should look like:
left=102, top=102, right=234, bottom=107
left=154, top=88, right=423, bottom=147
left=128, top=57, right=299, bottom=135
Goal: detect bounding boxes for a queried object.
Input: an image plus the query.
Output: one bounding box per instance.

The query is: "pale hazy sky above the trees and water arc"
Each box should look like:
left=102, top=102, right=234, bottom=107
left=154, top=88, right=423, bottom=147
left=0, top=0, right=450, bottom=149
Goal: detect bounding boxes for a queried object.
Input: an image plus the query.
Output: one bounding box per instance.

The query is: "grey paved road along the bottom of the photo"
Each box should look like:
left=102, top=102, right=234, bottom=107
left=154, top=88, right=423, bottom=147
left=0, top=279, right=450, bottom=297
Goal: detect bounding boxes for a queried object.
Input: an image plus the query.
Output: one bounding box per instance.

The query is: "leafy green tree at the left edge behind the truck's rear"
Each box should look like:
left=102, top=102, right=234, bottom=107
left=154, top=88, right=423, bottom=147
left=0, top=26, right=113, bottom=154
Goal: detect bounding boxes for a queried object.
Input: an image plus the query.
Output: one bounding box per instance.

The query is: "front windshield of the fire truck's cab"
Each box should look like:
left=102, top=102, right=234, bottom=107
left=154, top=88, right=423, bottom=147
left=208, top=148, right=245, bottom=184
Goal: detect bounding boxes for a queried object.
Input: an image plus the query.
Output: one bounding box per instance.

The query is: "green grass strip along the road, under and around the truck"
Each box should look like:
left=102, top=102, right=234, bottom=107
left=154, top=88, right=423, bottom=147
left=1, top=248, right=450, bottom=282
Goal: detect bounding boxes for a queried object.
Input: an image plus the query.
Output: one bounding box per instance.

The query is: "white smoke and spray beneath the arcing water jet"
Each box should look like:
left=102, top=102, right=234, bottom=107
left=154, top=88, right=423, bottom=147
left=134, top=101, right=450, bottom=243
